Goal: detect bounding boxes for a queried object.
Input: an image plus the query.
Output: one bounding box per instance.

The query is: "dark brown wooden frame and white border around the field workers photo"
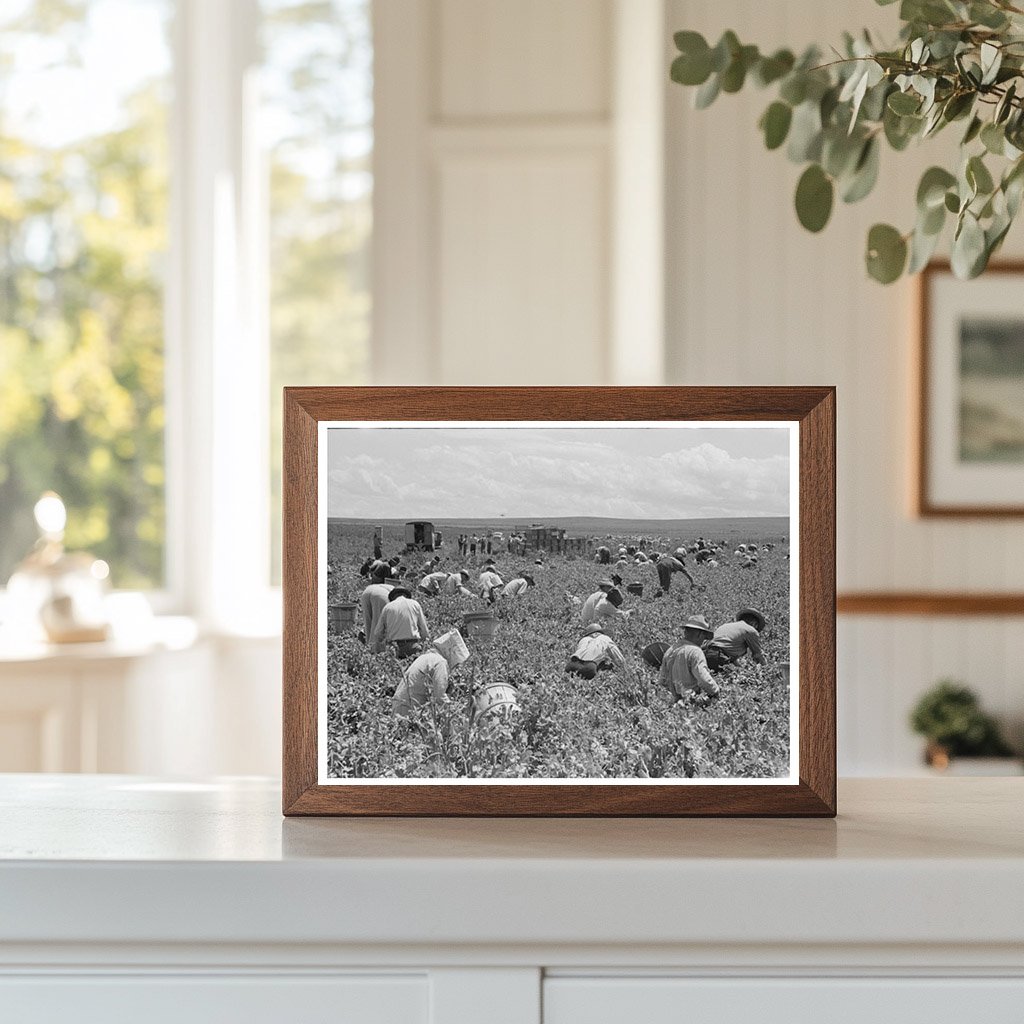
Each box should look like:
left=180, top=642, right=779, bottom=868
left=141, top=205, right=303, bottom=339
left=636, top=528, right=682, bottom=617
left=283, top=387, right=836, bottom=817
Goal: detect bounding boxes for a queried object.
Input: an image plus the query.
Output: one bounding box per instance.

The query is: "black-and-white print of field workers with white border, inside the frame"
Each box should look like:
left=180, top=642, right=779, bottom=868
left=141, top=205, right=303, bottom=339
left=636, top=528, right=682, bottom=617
left=319, top=422, right=798, bottom=784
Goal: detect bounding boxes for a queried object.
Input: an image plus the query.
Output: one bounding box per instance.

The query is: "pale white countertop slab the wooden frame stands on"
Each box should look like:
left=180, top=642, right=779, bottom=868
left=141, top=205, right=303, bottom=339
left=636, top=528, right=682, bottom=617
left=0, top=775, right=1024, bottom=949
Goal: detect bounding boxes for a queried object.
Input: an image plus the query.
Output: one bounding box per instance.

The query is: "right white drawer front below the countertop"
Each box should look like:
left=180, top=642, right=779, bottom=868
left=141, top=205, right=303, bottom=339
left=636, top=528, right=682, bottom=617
left=544, top=977, right=1024, bottom=1024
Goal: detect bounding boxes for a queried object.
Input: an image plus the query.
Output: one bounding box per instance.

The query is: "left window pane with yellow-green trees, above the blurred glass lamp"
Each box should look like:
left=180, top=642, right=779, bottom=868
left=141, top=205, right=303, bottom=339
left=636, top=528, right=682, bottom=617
left=0, top=0, right=172, bottom=588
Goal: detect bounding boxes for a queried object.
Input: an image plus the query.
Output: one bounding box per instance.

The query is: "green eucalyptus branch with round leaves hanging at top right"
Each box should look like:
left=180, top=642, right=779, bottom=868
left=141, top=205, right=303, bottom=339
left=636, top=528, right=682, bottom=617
left=671, top=0, right=1024, bottom=284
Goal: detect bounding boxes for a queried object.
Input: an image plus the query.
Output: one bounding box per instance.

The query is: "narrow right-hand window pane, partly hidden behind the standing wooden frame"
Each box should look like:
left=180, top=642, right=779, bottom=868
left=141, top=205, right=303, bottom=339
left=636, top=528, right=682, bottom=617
left=261, top=0, right=373, bottom=582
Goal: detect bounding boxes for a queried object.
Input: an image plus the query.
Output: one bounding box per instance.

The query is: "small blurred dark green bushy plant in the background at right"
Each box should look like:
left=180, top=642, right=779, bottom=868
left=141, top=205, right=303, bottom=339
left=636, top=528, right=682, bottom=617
left=910, top=679, right=1020, bottom=774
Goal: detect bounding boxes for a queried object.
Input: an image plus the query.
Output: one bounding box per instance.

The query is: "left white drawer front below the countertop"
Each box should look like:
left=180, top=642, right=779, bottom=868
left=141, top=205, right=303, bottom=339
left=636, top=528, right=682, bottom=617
left=0, top=975, right=429, bottom=1024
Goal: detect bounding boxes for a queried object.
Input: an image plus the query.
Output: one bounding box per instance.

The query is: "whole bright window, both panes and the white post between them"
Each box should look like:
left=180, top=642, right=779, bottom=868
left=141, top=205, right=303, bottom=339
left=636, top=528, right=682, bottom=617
left=0, top=0, right=373, bottom=614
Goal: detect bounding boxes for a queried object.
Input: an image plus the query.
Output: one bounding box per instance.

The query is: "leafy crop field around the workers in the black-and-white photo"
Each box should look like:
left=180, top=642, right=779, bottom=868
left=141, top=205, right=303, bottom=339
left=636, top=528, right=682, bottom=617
left=324, top=519, right=790, bottom=780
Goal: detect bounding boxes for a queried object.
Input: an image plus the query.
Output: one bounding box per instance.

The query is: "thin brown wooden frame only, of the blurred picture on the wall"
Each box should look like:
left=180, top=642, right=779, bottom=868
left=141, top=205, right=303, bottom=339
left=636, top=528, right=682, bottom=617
left=913, top=260, right=1024, bottom=519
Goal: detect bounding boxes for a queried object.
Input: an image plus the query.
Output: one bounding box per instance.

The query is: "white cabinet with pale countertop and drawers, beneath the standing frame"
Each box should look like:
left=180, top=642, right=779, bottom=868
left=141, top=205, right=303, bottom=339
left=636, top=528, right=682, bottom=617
left=0, top=775, right=1024, bottom=1024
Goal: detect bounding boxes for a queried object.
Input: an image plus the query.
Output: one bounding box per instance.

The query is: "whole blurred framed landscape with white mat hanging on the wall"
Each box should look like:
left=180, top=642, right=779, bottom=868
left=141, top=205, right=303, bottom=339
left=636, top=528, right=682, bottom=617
left=916, top=263, right=1024, bottom=516
